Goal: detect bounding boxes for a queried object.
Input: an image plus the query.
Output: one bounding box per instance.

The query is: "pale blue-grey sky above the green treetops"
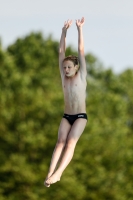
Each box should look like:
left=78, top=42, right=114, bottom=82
left=0, top=0, right=133, bottom=73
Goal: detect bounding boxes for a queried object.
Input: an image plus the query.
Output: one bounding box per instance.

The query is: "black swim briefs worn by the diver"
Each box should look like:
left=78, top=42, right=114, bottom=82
left=63, top=113, right=87, bottom=125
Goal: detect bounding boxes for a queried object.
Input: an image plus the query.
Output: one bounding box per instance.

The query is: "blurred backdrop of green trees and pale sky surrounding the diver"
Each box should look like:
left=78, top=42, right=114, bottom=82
left=0, top=0, right=133, bottom=200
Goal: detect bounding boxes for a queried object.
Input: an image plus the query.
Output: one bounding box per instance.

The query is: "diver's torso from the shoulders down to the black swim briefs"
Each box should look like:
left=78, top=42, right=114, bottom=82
left=62, top=71, right=86, bottom=115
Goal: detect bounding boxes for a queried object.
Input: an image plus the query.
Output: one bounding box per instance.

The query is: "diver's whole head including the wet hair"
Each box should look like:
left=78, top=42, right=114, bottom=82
left=63, top=55, right=79, bottom=77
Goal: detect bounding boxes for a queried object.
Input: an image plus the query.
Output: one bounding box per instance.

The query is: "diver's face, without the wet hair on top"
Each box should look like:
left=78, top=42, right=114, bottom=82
left=63, top=60, right=77, bottom=77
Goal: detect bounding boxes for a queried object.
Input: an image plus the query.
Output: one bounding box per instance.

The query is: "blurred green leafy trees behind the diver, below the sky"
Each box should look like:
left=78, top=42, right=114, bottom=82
left=0, top=33, right=133, bottom=200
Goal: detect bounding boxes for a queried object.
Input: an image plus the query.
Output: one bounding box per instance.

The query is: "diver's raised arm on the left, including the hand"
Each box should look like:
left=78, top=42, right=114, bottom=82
left=59, top=20, right=72, bottom=74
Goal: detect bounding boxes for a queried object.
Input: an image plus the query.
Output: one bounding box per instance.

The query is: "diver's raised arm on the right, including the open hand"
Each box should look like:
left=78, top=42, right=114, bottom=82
left=76, top=17, right=87, bottom=76
